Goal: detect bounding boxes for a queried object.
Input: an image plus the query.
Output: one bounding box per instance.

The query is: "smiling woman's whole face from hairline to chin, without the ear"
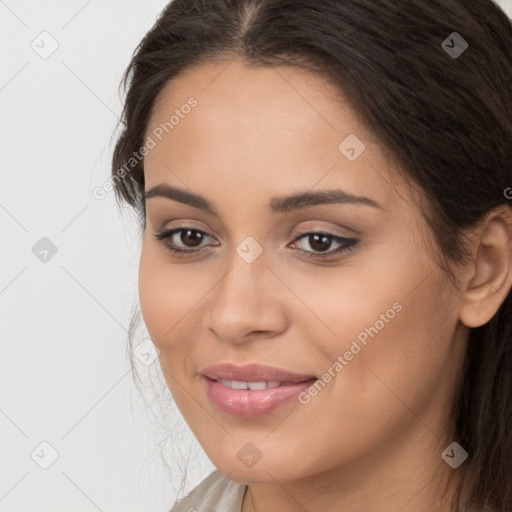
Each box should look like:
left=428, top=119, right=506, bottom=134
left=139, top=61, right=466, bottom=482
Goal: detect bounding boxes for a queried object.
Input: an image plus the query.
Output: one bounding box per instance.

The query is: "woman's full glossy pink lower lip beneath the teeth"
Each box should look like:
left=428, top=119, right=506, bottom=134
left=204, top=377, right=315, bottom=418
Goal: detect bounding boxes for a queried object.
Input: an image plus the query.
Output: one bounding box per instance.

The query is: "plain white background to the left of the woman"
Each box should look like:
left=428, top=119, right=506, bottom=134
left=0, top=0, right=512, bottom=512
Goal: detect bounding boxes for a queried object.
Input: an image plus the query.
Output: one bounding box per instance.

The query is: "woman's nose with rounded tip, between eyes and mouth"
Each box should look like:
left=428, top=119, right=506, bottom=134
left=208, top=254, right=287, bottom=344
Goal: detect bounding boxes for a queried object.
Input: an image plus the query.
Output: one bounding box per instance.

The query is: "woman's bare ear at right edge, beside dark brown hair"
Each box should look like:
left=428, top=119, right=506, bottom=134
left=459, top=204, right=512, bottom=327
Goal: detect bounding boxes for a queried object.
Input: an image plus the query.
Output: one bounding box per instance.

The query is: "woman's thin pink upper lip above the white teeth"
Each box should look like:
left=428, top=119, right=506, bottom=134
left=201, top=363, right=316, bottom=382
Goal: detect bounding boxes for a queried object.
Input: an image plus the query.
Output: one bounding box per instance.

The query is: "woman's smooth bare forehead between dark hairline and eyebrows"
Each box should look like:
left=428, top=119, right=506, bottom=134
left=145, top=61, right=408, bottom=210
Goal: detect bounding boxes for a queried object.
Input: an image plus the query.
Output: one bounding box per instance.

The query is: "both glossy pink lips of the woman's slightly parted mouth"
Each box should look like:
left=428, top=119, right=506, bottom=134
left=201, top=363, right=316, bottom=418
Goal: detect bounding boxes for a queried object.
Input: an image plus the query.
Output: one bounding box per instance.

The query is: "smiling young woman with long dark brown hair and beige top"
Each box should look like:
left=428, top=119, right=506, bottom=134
left=112, top=0, right=512, bottom=512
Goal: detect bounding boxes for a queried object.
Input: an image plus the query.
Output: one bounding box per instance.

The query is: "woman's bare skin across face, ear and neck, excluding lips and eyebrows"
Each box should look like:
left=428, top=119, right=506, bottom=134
left=139, top=60, right=512, bottom=512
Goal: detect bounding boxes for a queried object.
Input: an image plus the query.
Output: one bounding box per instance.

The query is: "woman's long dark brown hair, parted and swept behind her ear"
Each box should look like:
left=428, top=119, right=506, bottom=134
left=112, top=0, right=512, bottom=512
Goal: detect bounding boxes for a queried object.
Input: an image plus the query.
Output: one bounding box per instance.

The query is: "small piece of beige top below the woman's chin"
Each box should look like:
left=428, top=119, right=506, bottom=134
left=170, top=469, right=247, bottom=512
